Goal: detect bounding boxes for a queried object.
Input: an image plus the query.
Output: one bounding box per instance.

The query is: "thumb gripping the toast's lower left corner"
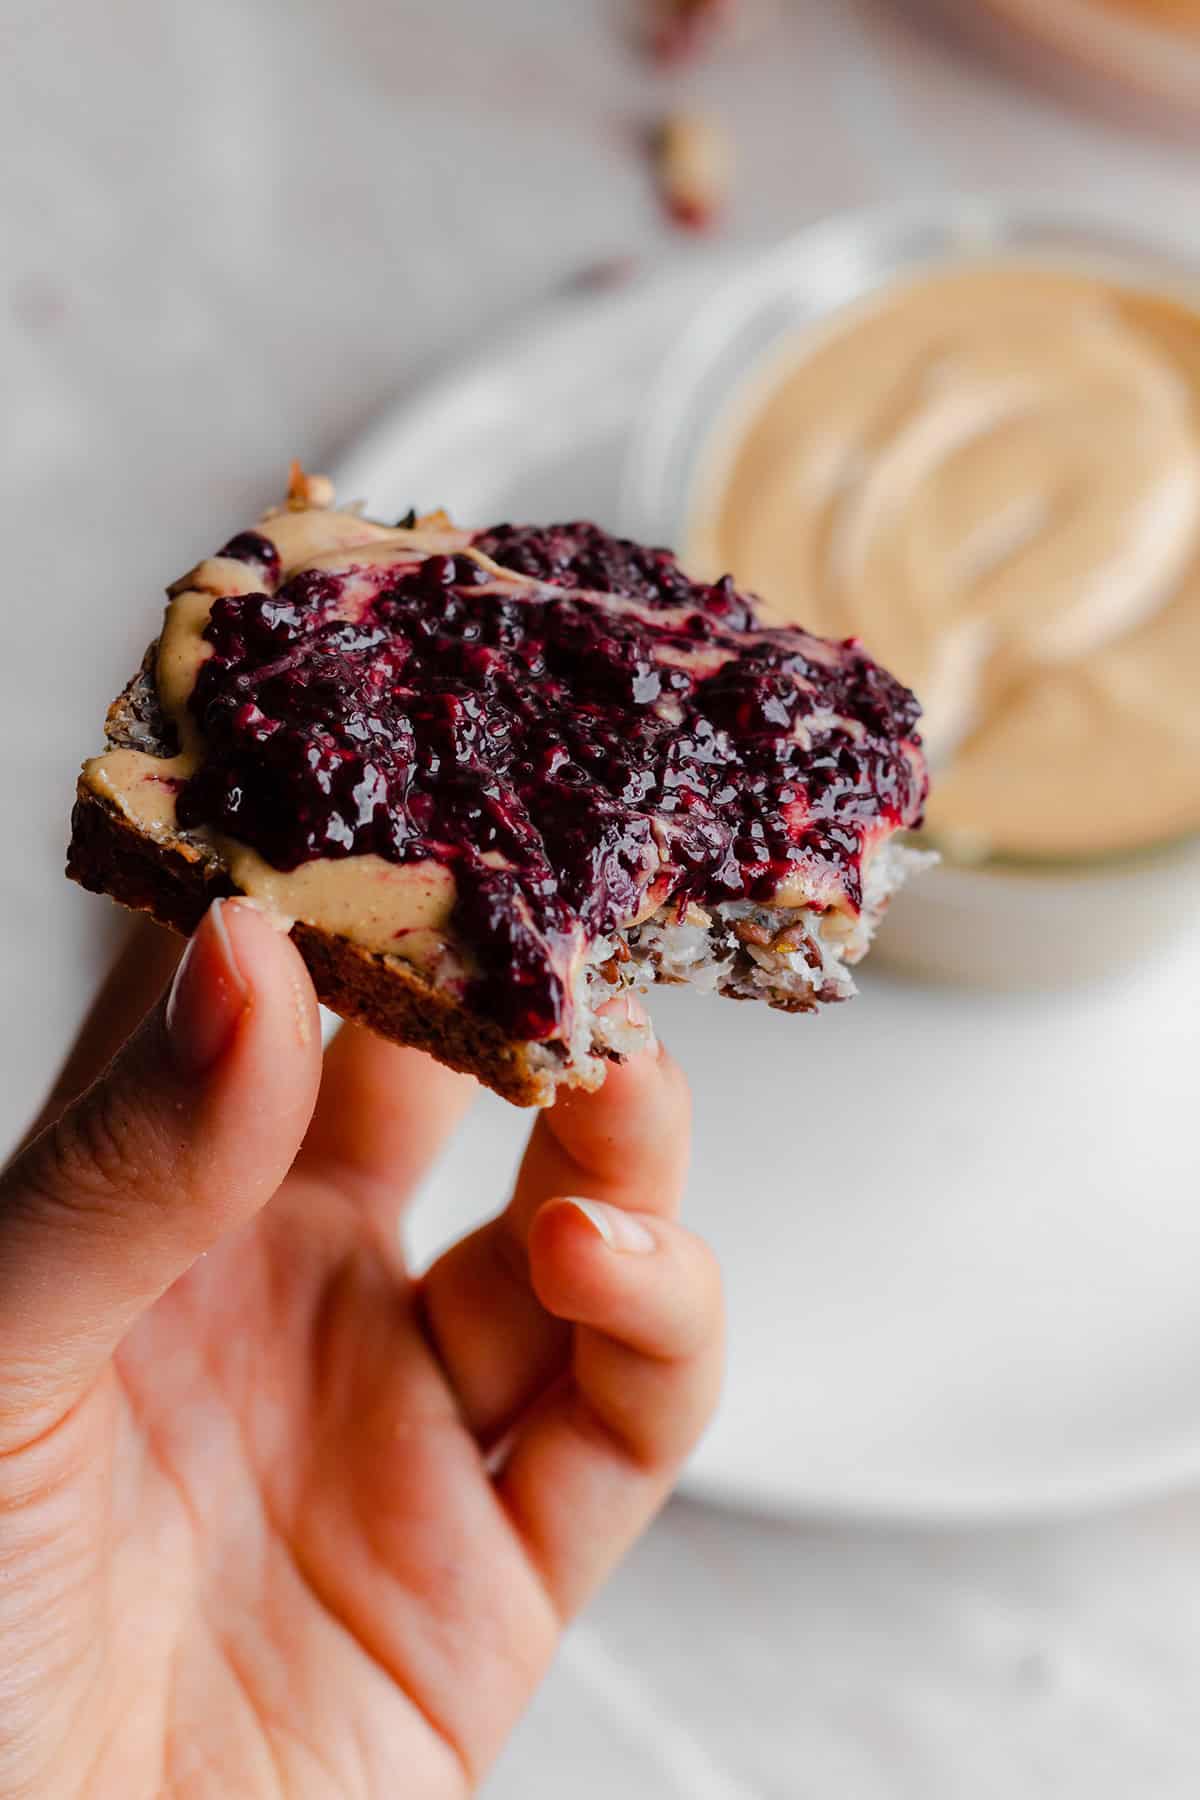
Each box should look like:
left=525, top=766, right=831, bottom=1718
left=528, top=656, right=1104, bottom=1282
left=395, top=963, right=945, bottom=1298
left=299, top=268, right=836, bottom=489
left=0, top=900, right=320, bottom=1418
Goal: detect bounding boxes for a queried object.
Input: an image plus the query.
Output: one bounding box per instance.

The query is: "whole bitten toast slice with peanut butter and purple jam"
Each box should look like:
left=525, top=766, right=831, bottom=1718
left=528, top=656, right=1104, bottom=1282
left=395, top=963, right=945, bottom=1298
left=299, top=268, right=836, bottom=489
left=67, top=477, right=925, bottom=1105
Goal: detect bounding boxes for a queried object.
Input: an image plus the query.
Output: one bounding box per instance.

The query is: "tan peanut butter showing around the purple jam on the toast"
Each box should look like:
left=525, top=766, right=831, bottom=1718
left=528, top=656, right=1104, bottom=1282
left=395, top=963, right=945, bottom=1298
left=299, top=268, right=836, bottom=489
left=85, top=473, right=923, bottom=994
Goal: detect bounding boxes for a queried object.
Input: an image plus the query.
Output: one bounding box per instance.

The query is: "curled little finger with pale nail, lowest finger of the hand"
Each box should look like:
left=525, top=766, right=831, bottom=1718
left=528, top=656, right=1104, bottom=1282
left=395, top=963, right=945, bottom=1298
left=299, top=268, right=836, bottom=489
left=497, top=1199, right=723, bottom=1616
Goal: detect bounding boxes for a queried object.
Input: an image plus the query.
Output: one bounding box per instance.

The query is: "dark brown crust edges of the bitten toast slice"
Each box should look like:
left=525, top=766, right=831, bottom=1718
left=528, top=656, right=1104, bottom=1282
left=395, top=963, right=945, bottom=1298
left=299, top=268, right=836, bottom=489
left=67, top=644, right=572, bottom=1107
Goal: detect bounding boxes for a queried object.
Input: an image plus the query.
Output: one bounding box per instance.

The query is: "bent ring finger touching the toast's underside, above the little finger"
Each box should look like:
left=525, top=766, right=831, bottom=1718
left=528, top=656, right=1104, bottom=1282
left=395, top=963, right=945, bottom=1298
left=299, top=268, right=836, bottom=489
left=423, top=1048, right=689, bottom=1442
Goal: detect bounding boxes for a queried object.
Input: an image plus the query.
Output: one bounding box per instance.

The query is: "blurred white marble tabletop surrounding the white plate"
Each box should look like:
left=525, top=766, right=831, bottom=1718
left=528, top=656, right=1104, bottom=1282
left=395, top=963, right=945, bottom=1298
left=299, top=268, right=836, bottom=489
left=0, top=0, right=1200, bottom=1800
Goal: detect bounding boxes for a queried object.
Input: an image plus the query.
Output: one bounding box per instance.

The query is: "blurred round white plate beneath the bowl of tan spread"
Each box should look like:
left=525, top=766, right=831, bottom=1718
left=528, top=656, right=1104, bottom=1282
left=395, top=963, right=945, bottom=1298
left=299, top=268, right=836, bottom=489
left=338, top=265, right=1200, bottom=1519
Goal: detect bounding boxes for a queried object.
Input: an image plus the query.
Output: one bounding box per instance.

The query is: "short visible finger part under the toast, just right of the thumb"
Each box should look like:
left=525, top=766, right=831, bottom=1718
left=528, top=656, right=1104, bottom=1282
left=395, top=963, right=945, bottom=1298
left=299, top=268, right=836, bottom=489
left=297, top=1024, right=479, bottom=1247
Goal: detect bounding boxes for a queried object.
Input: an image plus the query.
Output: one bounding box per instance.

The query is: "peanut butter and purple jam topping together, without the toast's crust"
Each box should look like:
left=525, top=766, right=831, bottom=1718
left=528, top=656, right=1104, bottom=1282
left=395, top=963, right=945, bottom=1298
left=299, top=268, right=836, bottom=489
left=83, top=475, right=927, bottom=1040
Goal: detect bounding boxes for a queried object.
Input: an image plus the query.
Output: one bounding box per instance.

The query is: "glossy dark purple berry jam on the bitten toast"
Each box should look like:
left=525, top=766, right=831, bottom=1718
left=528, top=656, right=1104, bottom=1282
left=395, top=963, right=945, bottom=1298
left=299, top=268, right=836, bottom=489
left=180, top=524, right=925, bottom=1039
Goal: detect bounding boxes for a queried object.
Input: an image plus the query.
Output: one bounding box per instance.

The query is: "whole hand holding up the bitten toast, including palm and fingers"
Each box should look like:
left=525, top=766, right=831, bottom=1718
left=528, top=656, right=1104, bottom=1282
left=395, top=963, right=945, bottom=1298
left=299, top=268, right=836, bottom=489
left=0, top=902, right=720, bottom=1800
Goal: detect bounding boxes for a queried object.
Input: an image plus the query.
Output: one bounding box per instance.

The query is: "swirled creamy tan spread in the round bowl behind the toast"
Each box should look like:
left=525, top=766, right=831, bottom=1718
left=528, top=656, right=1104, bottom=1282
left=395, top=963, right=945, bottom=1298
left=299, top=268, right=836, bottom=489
left=687, top=265, right=1200, bottom=855
